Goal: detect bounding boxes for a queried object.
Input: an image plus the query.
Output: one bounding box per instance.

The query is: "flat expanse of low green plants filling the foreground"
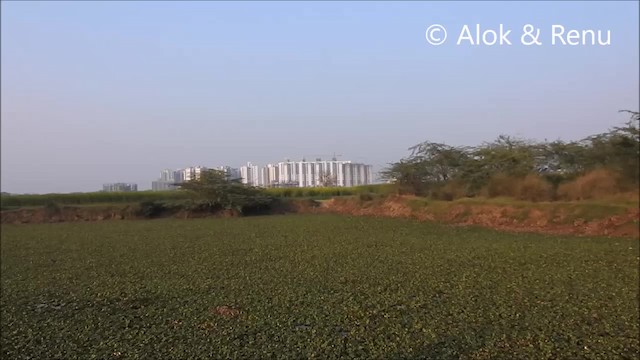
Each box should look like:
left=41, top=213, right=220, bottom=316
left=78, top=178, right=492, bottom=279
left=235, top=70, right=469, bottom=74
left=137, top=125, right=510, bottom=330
left=0, top=215, right=640, bottom=359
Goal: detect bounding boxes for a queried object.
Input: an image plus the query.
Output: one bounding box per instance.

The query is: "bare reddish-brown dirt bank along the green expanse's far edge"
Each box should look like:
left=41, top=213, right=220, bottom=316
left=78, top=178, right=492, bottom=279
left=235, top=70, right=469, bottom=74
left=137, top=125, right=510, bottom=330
left=1, top=197, right=640, bottom=237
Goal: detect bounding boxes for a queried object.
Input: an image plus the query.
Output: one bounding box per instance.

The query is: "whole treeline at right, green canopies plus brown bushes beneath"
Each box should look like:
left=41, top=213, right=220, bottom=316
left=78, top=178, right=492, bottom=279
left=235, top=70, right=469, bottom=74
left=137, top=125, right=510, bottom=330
left=382, top=110, right=640, bottom=201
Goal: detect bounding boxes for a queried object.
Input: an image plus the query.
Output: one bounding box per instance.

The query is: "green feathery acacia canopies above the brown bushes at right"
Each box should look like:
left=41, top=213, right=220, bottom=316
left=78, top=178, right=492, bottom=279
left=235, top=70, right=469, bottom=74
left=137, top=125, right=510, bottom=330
left=381, top=110, right=640, bottom=195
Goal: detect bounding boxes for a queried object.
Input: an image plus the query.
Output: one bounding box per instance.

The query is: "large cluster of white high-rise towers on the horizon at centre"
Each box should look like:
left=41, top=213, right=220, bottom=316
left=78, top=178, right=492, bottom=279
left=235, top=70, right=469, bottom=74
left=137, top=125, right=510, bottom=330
left=151, top=158, right=374, bottom=191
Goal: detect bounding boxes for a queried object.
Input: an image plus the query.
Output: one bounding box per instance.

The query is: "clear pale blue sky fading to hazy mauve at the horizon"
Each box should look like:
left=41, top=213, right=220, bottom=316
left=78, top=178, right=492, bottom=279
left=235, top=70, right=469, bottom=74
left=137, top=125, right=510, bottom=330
left=1, top=1, right=640, bottom=193
